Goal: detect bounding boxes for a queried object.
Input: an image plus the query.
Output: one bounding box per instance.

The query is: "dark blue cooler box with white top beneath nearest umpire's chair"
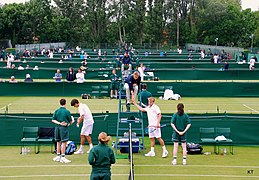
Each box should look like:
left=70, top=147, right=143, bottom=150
left=119, top=138, right=140, bottom=153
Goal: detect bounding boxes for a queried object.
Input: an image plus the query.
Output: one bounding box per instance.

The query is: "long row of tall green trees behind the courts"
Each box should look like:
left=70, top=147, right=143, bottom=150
left=0, top=0, right=259, bottom=47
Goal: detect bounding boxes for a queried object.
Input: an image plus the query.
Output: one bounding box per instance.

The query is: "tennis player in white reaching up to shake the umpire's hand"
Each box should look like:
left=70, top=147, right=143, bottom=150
left=132, top=97, right=168, bottom=158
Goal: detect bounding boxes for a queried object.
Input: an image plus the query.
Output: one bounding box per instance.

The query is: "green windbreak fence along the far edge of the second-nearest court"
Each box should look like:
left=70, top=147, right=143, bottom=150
left=0, top=81, right=259, bottom=97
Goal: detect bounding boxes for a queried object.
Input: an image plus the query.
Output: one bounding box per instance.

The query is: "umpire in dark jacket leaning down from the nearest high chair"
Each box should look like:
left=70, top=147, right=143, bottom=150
left=124, top=71, right=141, bottom=111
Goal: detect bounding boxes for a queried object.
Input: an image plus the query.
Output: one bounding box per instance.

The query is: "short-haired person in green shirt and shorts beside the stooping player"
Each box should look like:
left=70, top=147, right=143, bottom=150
left=52, top=99, right=73, bottom=163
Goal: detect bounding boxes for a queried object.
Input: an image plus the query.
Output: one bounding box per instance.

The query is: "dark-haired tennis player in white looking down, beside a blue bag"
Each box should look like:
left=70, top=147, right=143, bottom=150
left=71, top=99, right=94, bottom=154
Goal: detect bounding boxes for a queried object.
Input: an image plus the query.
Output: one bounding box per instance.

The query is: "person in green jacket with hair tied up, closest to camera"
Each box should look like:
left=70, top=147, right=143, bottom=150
left=88, top=132, right=115, bottom=180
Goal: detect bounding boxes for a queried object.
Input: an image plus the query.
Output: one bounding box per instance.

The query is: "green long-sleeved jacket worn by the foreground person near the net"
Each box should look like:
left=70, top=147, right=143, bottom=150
left=88, top=143, right=115, bottom=173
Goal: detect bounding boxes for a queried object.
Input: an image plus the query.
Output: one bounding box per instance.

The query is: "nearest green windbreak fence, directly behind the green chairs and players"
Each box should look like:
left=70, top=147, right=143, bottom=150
left=0, top=113, right=259, bottom=145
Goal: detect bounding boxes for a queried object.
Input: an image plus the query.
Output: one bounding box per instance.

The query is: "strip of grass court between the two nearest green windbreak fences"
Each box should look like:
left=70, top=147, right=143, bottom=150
left=0, top=97, right=259, bottom=114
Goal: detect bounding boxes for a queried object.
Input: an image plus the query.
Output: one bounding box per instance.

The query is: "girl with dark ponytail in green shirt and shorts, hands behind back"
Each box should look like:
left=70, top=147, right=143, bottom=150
left=171, top=103, right=191, bottom=165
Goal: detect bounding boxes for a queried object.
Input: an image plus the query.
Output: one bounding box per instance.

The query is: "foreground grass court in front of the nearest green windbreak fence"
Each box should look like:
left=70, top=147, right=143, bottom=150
left=0, top=145, right=259, bottom=180
